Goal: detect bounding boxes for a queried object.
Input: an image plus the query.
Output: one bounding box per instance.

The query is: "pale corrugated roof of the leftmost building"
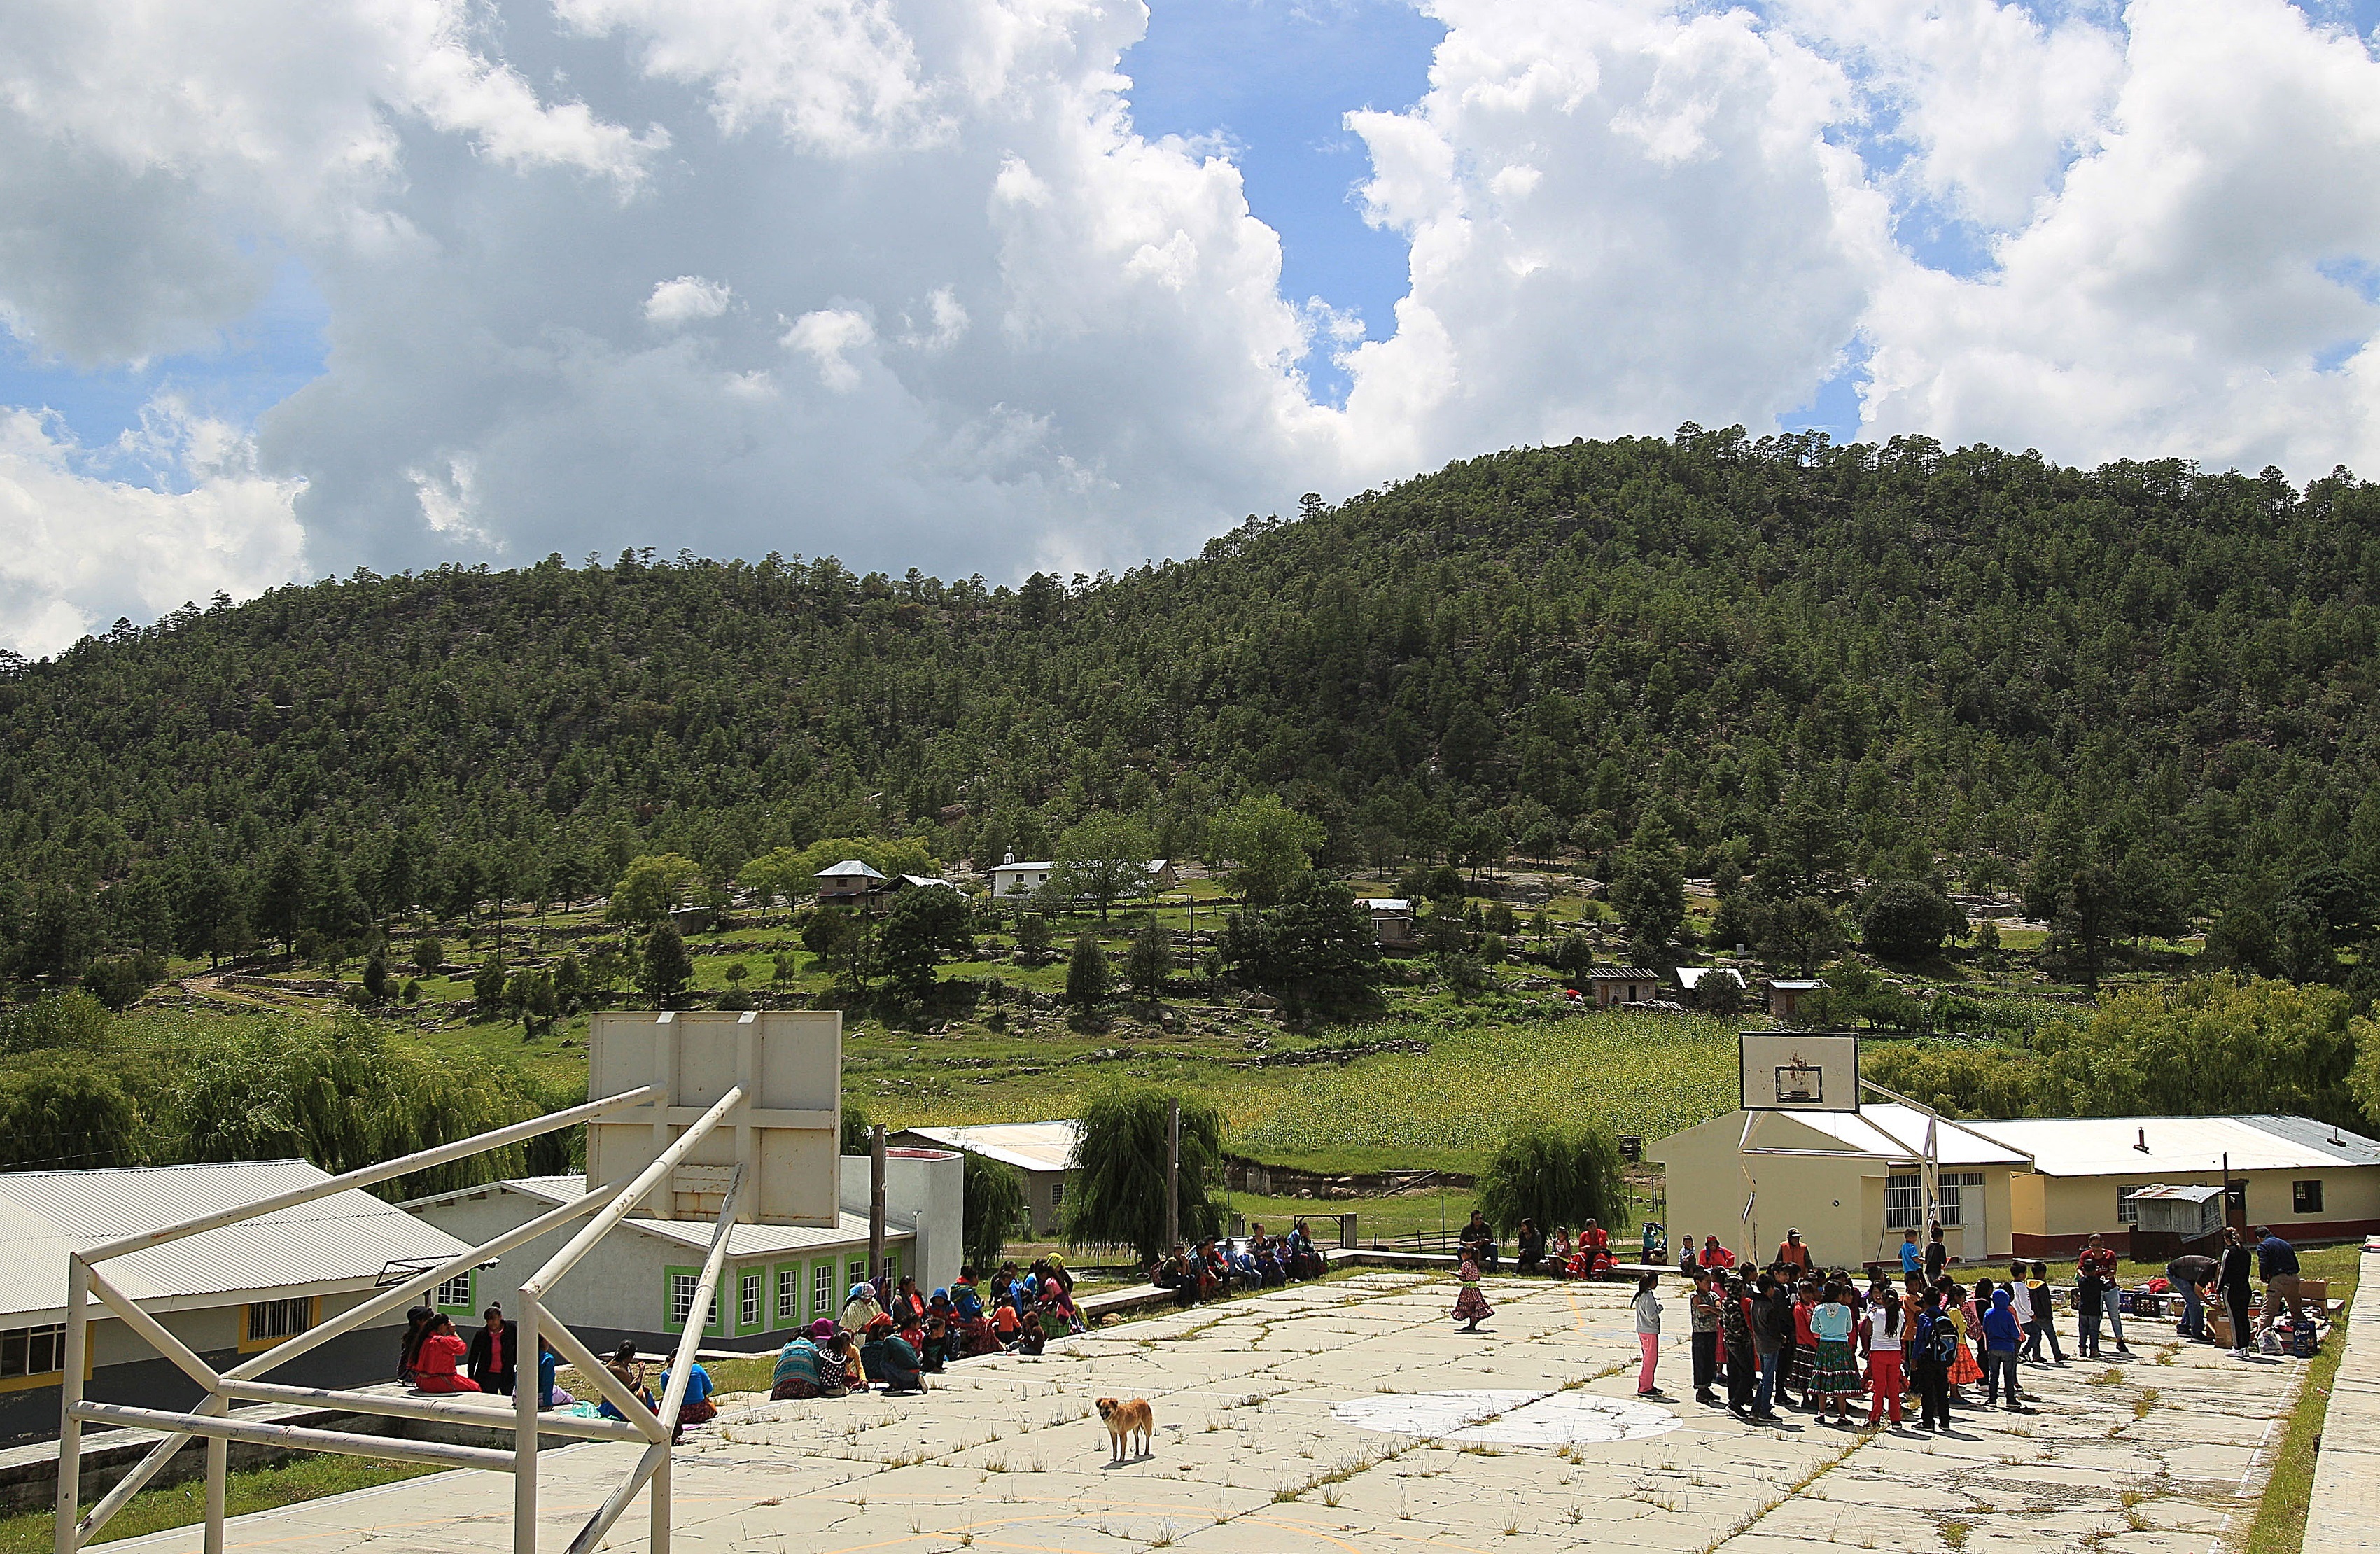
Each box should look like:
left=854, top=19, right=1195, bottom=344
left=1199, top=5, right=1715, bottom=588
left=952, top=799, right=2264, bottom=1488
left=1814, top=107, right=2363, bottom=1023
left=0, top=1159, right=469, bottom=1321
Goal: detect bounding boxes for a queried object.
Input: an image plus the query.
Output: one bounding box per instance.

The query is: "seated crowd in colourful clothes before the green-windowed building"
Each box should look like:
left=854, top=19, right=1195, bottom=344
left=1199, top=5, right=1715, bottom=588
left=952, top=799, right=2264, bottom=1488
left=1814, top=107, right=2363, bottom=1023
left=769, top=1256, right=1085, bottom=1399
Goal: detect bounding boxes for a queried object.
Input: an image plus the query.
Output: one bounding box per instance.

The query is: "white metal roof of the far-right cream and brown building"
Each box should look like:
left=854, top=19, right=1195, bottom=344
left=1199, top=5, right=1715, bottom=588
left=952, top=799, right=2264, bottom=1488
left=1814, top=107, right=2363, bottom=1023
left=1970, top=1116, right=2380, bottom=1180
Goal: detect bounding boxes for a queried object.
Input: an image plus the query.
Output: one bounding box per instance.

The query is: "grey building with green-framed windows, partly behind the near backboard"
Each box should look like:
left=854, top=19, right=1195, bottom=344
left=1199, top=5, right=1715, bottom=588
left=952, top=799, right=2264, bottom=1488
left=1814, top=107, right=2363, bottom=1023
left=405, top=1147, right=966, bottom=1350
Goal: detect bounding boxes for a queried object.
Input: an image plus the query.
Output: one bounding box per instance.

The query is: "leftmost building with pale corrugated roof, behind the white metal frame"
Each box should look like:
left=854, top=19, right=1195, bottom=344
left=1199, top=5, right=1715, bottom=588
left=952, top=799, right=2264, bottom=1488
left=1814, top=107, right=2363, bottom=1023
left=0, top=1159, right=469, bottom=1440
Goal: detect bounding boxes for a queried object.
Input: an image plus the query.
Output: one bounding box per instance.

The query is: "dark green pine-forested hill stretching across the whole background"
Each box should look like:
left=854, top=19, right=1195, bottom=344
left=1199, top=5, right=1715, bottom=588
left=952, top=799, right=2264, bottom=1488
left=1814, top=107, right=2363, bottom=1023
left=0, top=428, right=2380, bottom=973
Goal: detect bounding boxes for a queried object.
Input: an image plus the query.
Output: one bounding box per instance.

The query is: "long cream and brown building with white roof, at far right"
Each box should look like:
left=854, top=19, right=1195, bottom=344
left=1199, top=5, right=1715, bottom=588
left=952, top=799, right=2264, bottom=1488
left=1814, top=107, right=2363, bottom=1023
left=1968, top=1114, right=2380, bottom=1256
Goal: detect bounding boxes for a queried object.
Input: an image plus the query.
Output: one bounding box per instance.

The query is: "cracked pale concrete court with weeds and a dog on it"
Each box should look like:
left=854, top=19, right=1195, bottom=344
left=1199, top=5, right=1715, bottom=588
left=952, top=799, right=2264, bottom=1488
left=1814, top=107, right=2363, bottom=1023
left=114, top=1270, right=2311, bottom=1554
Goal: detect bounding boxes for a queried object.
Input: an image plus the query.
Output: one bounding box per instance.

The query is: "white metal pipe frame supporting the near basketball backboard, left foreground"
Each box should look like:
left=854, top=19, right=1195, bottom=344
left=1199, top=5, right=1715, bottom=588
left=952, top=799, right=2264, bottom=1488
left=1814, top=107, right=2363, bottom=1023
left=57, top=1085, right=745, bottom=1554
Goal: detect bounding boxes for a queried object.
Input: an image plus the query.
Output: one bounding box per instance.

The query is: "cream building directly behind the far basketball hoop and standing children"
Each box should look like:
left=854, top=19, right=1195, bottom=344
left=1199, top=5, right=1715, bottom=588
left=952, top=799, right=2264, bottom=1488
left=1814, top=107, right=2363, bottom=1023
left=1644, top=1104, right=2033, bottom=1268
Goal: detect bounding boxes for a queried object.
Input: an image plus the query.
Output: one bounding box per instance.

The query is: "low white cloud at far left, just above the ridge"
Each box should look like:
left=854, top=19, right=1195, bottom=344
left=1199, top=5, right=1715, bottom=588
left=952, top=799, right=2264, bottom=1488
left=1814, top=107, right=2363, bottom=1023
left=0, top=400, right=304, bottom=654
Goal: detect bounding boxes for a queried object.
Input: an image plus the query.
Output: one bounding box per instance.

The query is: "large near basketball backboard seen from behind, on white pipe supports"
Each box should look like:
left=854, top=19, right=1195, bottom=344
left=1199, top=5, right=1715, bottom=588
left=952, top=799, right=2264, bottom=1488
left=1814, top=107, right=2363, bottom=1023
left=588, top=1009, right=843, bottom=1226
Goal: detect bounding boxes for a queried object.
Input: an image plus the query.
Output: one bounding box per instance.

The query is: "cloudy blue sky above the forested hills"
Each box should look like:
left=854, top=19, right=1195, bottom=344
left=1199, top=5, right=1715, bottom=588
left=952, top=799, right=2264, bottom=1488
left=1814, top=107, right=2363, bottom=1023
left=0, top=0, right=2380, bottom=657
